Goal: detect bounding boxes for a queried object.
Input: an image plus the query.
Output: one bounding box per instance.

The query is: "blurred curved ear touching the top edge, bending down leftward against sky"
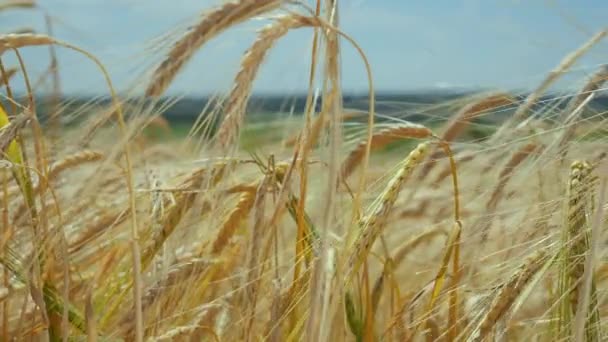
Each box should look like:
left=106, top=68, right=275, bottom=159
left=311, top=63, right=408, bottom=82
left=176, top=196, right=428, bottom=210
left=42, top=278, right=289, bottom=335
left=146, top=0, right=282, bottom=97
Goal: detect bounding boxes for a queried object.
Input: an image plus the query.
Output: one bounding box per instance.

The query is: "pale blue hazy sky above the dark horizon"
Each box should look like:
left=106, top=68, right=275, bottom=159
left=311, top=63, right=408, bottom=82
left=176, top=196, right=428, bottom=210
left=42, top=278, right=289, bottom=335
left=0, top=0, right=608, bottom=96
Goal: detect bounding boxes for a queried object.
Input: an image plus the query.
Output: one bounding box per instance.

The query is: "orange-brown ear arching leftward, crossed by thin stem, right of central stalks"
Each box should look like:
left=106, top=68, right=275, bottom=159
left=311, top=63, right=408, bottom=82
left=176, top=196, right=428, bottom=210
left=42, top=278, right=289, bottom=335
left=342, top=124, right=433, bottom=178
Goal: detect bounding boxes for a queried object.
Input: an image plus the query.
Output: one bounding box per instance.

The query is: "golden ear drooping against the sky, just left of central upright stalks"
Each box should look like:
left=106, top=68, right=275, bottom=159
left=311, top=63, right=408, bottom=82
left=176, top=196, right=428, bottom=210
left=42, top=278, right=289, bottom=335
left=217, top=14, right=319, bottom=148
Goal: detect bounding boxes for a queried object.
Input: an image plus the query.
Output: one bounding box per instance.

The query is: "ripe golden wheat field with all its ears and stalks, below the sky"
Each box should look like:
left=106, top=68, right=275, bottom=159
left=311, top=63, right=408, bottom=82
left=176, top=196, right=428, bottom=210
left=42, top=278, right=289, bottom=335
left=0, top=0, right=608, bottom=341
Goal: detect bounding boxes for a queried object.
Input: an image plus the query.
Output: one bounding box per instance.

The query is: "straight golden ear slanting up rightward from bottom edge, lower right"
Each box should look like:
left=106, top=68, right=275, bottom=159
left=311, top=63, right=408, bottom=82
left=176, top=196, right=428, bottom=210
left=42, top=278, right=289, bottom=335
left=475, top=251, right=546, bottom=341
